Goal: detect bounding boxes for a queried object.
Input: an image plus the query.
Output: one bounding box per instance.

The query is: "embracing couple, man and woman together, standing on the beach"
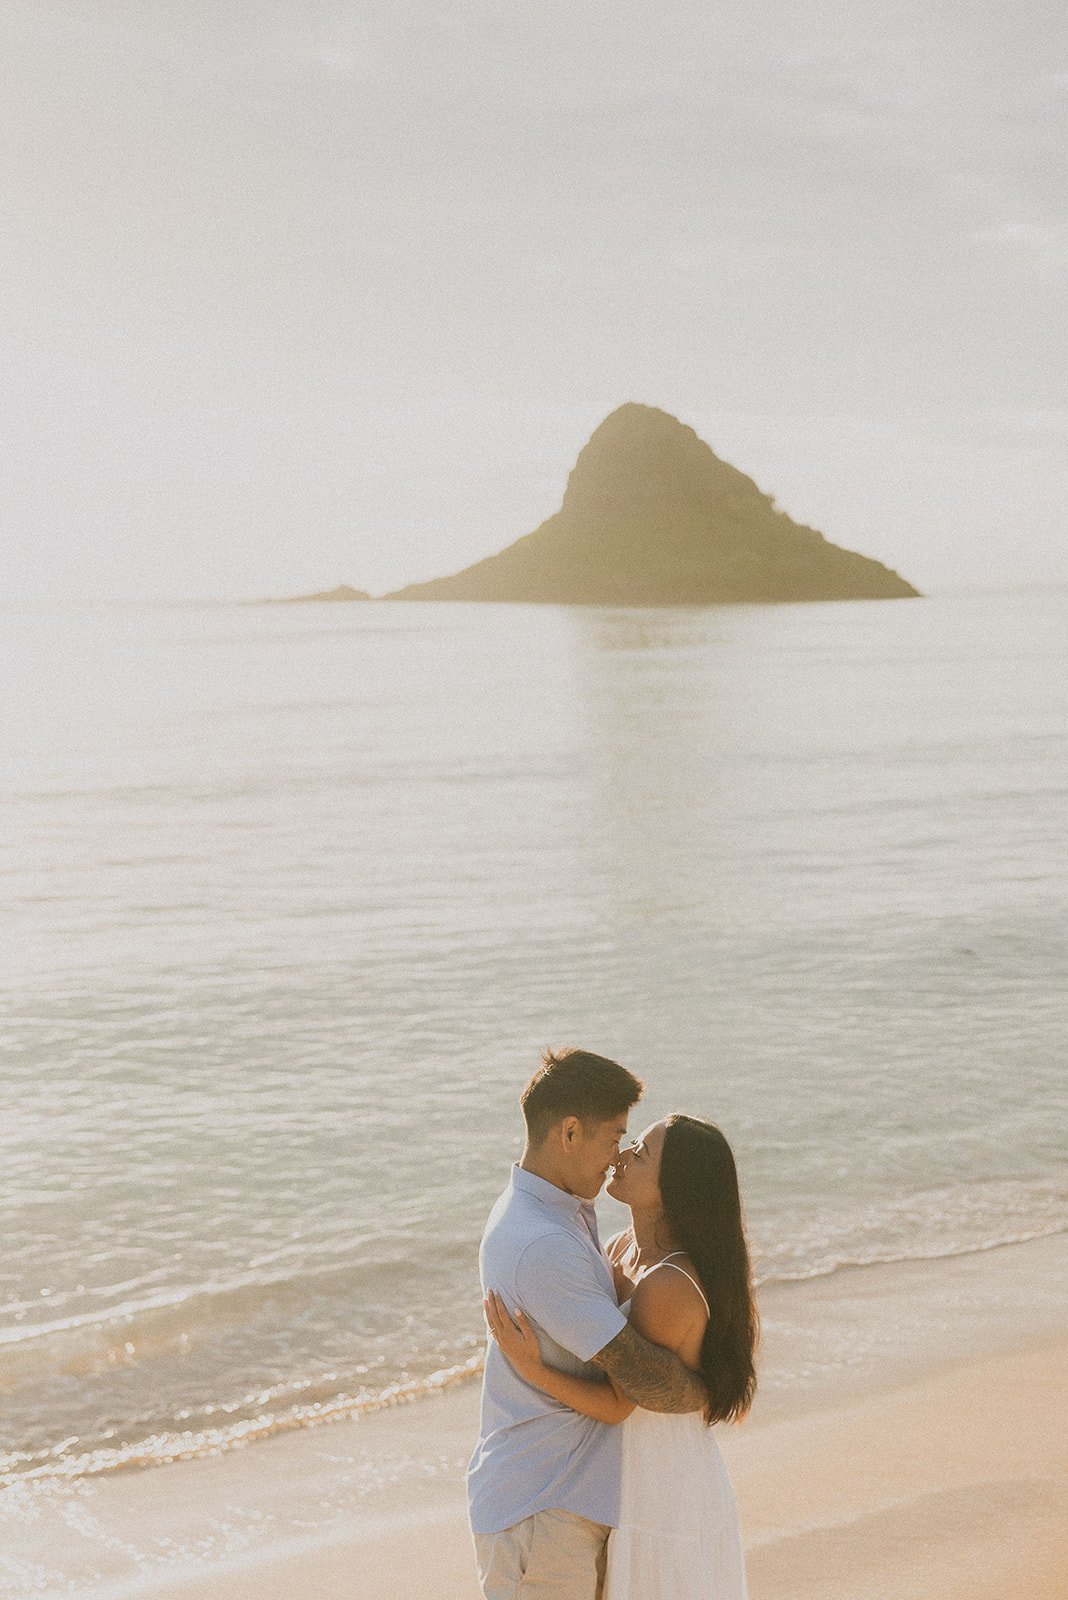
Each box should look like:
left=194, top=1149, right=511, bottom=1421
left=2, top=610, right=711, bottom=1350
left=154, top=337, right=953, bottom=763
left=467, top=1050, right=756, bottom=1600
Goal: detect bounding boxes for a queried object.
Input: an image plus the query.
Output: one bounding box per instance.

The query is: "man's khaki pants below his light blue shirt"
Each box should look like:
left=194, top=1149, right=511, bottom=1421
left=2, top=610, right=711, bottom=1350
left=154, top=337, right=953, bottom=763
left=475, top=1510, right=611, bottom=1600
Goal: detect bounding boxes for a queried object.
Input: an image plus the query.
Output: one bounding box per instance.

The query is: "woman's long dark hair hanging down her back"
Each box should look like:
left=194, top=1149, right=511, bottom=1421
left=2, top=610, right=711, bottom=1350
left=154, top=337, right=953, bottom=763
left=660, top=1112, right=758, bottom=1422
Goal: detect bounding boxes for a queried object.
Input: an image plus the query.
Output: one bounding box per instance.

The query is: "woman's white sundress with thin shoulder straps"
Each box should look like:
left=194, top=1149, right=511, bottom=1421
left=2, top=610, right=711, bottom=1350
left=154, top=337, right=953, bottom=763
left=604, top=1259, right=748, bottom=1600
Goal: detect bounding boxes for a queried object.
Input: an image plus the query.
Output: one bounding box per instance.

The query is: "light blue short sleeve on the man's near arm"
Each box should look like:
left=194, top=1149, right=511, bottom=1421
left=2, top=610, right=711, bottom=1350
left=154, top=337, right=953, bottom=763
left=515, top=1229, right=627, bottom=1362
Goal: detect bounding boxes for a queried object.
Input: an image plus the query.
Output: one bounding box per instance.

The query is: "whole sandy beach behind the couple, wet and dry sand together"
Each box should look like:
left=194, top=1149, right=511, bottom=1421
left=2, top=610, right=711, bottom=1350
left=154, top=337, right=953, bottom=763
left=0, top=1235, right=1068, bottom=1600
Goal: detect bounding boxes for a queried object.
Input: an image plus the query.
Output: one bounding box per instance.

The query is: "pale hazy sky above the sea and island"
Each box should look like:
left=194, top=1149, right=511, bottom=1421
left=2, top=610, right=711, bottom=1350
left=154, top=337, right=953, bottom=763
left=0, top=0, right=1068, bottom=598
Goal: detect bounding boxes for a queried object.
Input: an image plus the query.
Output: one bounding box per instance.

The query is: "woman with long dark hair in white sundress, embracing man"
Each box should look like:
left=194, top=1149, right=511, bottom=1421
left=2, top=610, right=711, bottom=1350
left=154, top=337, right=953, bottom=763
left=486, top=1115, right=756, bottom=1600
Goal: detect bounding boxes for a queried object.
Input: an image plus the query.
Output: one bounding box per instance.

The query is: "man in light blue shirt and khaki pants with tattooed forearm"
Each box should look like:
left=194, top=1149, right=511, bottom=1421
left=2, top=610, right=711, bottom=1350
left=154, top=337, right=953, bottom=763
left=467, top=1050, right=707, bottom=1600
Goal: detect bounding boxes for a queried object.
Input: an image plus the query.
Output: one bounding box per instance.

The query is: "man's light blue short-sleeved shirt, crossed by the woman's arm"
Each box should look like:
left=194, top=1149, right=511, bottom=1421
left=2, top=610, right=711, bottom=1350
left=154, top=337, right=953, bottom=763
left=467, top=1166, right=627, bottom=1533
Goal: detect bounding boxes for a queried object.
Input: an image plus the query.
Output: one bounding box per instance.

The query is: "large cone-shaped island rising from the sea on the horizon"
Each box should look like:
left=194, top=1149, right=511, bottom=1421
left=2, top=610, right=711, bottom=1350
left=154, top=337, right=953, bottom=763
left=385, top=405, right=918, bottom=605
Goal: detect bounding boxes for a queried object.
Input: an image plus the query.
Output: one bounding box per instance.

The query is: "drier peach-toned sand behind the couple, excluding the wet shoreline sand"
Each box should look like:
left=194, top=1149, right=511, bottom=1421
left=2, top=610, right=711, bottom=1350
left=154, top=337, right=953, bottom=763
left=147, top=1341, right=1068, bottom=1600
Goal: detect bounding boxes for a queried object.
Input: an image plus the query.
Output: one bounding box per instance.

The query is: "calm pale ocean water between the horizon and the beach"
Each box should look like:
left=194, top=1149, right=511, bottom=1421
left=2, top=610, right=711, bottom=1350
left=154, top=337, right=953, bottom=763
left=0, top=590, right=1068, bottom=1480
